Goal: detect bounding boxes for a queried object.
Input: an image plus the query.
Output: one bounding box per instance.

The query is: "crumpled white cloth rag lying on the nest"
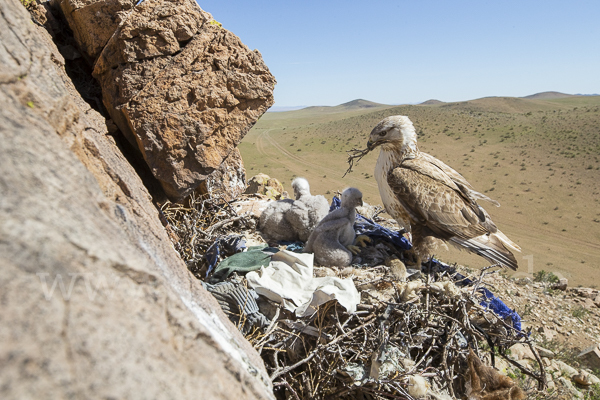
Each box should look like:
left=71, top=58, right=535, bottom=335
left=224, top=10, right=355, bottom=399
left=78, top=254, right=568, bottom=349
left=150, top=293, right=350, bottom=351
left=246, top=250, right=360, bottom=317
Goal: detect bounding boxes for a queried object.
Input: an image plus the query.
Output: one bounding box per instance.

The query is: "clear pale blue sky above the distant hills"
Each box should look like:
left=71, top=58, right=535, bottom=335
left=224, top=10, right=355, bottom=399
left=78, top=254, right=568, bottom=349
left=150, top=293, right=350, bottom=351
left=199, top=0, right=600, bottom=107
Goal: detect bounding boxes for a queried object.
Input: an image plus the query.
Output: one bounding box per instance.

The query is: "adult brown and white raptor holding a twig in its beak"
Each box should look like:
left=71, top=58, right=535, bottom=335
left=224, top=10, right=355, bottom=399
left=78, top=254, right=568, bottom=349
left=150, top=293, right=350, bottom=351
left=367, top=115, right=521, bottom=270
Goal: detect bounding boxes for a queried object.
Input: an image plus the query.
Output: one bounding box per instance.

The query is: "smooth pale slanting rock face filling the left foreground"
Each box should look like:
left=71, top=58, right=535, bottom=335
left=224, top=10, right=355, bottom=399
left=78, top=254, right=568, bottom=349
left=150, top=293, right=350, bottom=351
left=0, top=0, right=273, bottom=399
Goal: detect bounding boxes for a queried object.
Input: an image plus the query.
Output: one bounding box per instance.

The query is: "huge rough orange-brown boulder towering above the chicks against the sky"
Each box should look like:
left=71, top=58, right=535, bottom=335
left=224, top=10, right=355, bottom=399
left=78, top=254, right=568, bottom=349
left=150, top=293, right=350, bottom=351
left=93, top=0, right=275, bottom=200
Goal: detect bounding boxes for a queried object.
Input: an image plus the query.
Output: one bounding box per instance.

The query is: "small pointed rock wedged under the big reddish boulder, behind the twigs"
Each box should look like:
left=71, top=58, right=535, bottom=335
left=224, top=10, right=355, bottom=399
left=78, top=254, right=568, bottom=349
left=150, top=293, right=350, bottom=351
left=196, top=148, right=246, bottom=201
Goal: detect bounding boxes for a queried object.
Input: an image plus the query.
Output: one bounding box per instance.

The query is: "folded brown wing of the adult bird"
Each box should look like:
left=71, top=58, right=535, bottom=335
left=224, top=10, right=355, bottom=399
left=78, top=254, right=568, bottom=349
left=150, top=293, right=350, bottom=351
left=388, top=160, right=489, bottom=239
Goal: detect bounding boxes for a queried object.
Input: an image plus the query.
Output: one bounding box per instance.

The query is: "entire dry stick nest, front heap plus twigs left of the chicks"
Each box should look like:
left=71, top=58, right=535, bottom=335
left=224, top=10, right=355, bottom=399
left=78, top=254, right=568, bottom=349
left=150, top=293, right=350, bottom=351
left=162, top=197, right=545, bottom=400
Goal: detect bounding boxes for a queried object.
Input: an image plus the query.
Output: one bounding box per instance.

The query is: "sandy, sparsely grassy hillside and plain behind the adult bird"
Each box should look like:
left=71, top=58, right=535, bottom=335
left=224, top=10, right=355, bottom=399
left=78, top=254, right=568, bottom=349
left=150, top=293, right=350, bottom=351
left=239, top=96, right=600, bottom=286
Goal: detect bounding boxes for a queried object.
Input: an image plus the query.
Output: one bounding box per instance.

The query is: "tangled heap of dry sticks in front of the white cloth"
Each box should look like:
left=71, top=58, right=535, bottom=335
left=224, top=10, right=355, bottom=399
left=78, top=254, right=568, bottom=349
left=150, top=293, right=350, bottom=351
left=248, top=262, right=544, bottom=399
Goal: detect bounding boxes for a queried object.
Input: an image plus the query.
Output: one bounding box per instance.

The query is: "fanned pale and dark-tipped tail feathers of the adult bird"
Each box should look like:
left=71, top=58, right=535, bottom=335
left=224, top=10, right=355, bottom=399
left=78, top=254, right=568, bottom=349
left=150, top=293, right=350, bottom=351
left=450, top=231, right=520, bottom=271
